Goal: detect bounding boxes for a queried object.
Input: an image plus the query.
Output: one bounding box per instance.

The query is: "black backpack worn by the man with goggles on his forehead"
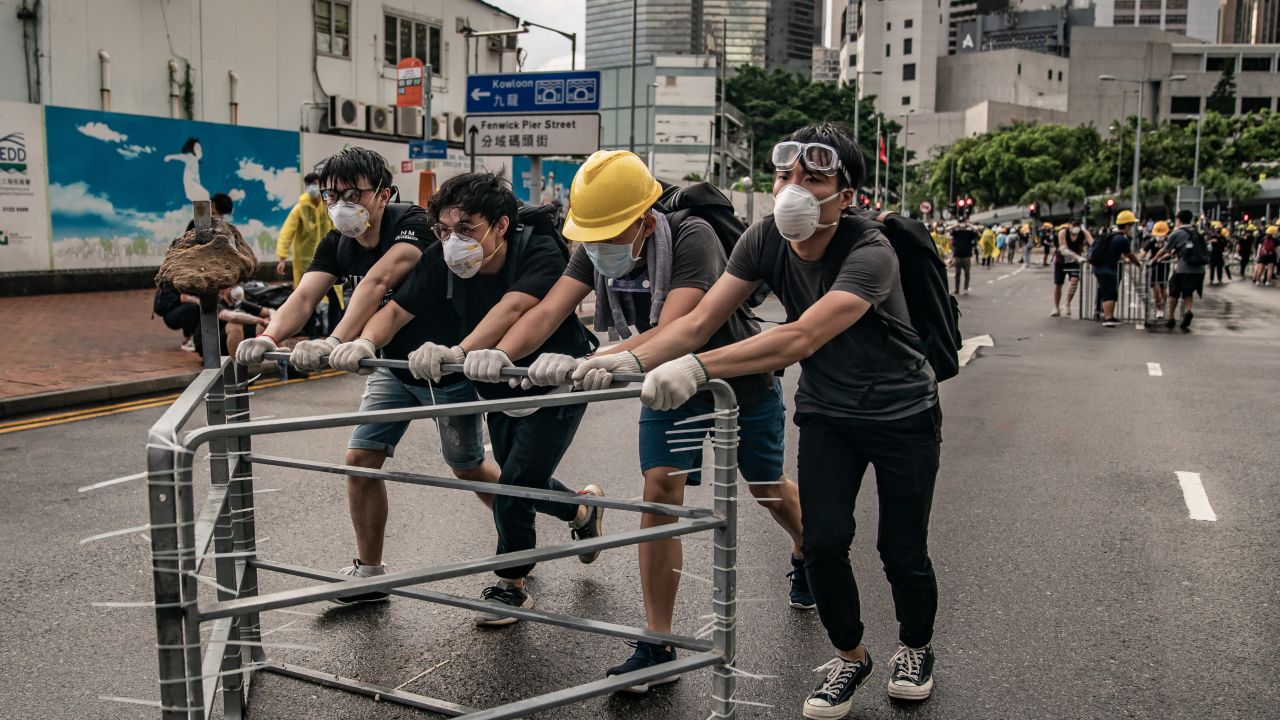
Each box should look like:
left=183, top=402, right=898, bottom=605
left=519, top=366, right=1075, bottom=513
left=768, top=210, right=963, bottom=383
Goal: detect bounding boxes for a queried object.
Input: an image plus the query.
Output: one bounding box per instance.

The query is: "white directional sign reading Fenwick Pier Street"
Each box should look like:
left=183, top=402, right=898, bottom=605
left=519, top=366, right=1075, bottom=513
left=465, top=113, right=600, bottom=155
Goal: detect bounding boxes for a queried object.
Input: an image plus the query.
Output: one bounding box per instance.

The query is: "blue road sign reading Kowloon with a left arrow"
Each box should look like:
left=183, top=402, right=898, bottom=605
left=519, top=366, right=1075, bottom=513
left=467, top=70, right=600, bottom=115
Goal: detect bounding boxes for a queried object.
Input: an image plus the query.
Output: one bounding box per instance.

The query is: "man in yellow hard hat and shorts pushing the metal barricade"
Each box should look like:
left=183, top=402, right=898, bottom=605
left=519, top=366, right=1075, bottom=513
left=483, top=150, right=813, bottom=692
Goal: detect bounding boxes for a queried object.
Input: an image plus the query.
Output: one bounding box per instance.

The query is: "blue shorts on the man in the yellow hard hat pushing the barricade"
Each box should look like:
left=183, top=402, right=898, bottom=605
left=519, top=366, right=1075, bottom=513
left=640, top=378, right=787, bottom=486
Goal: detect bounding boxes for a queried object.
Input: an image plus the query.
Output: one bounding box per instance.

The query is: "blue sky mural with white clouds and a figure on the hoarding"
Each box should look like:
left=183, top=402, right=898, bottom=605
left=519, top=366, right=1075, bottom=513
left=45, top=106, right=302, bottom=269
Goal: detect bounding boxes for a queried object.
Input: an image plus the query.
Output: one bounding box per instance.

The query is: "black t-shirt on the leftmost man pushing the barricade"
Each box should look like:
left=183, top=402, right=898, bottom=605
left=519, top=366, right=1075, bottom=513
left=307, top=205, right=462, bottom=386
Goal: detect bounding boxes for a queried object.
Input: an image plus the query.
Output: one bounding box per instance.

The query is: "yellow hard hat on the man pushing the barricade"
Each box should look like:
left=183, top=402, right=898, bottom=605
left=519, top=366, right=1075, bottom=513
left=564, top=150, right=662, bottom=242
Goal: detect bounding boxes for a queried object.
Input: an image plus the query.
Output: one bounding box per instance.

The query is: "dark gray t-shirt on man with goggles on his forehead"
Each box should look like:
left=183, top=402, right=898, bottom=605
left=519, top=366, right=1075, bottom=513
left=728, top=218, right=938, bottom=420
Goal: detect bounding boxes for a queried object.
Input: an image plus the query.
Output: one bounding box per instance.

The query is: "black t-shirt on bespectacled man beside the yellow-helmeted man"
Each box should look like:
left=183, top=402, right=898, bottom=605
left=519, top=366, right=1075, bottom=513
left=394, top=229, right=590, bottom=400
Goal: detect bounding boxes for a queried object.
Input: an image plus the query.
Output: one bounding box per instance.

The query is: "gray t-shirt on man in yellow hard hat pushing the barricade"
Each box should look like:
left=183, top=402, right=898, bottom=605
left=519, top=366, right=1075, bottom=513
left=564, top=217, right=773, bottom=404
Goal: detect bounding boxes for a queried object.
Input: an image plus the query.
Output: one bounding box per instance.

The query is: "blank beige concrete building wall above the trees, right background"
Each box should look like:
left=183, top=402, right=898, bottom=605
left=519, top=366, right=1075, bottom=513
left=937, top=50, right=1070, bottom=113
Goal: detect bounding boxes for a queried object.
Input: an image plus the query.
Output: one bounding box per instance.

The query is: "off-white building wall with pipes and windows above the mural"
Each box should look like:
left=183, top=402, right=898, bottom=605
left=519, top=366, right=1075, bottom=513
left=0, top=0, right=515, bottom=129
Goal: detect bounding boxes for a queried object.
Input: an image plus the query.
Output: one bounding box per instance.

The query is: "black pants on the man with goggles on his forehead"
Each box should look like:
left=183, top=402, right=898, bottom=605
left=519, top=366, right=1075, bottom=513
left=796, top=405, right=942, bottom=651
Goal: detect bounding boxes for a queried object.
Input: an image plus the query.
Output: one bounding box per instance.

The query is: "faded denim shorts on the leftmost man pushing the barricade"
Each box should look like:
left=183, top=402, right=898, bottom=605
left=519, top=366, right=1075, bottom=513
left=347, top=368, right=484, bottom=470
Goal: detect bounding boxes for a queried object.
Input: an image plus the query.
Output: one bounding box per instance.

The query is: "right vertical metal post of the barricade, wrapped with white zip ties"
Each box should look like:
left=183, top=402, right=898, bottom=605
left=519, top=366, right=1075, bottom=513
left=712, top=383, right=737, bottom=719
